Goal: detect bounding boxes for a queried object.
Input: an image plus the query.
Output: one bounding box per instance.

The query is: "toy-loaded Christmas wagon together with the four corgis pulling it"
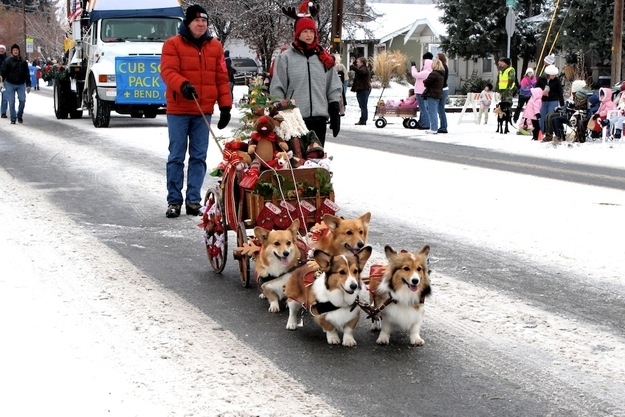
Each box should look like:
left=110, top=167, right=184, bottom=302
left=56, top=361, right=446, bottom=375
left=198, top=79, right=430, bottom=347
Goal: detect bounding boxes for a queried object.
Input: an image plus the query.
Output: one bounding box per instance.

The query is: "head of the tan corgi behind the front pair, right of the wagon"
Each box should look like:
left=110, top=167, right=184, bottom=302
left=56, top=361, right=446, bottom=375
left=315, top=213, right=371, bottom=255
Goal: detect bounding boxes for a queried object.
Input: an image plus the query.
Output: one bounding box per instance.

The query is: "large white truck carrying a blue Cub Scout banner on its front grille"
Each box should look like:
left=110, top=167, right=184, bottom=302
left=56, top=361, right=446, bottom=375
left=54, top=0, right=184, bottom=127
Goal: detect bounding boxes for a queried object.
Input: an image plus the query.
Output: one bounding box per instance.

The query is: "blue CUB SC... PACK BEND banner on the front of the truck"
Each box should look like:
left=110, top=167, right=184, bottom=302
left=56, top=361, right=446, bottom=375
left=115, top=56, right=165, bottom=106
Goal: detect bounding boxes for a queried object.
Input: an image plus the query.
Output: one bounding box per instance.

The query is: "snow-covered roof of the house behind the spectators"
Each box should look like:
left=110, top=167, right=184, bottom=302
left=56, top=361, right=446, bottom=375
left=350, top=2, right=447, bottom=42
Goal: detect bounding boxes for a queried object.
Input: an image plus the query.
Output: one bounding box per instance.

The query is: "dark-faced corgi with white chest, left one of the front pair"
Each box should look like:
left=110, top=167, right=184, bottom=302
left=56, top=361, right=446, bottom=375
left=285, top=246, right=372, bottom=346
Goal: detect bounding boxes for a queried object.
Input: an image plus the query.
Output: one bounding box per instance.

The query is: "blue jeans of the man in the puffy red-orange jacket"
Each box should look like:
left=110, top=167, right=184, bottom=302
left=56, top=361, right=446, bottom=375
left=167, top=114, right=211, bottom=205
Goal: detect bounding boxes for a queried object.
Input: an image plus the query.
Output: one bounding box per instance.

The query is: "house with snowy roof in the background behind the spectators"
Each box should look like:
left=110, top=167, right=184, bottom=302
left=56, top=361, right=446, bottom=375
left=342, top=0, right=497, bottom=94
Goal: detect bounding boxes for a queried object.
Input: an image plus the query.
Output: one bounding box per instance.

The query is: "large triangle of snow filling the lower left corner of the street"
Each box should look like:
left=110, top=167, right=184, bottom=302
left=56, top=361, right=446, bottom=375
left=0, top=171, right=339, bottom=417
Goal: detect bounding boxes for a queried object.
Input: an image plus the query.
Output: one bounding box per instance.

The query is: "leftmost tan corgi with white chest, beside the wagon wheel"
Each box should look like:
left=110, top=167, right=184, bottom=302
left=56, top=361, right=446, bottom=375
left=254, top=219, right=301, bottom=313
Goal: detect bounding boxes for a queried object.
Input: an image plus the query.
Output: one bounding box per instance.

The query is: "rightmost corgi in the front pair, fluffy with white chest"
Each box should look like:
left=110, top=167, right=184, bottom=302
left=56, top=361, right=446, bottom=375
left=369, top=245, right=431, bottom=346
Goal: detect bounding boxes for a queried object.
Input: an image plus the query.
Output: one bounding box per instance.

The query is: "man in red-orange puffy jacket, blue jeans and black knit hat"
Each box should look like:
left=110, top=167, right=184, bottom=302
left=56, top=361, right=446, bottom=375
left=161, top=5, right=232, bottom=218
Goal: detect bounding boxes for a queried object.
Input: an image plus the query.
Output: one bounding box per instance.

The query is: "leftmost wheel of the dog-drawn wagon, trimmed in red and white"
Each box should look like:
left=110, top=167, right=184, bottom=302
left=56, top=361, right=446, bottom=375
left=202, top=190, right=228, bottom=273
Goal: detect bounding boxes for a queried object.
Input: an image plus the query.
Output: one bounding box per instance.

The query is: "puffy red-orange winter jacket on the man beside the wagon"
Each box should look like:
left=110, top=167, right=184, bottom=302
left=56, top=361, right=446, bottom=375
left=161, top=25, right=232, bottom=115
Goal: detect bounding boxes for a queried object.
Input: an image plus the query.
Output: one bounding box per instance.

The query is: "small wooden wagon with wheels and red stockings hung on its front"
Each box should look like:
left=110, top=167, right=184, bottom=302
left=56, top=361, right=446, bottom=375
left=200, top=168, right=338, bottom=287
